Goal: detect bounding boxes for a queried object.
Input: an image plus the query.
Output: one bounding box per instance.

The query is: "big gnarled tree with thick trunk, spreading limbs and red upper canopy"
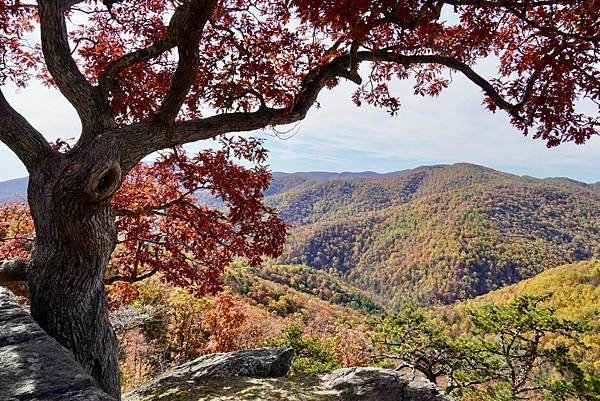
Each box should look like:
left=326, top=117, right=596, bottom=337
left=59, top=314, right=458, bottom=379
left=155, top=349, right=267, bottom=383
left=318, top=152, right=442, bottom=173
left=0, top=0, right=600, bottom=397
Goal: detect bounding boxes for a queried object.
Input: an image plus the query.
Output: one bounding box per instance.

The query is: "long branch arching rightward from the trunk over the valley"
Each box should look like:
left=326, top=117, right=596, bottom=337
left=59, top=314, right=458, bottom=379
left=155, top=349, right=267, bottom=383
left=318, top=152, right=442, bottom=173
left=120, top=51, right=519, bottom=163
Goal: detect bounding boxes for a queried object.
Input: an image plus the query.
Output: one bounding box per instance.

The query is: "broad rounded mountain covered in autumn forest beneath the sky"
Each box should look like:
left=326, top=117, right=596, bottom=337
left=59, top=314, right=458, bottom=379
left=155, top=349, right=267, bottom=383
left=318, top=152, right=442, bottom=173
left=268, top=163, right=600, bottom=306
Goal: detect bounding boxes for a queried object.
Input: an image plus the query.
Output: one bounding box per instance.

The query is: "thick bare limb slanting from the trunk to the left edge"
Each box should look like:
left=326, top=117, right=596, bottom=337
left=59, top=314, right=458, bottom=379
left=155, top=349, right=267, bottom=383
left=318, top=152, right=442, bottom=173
left=0, top=91, right=52, bottom=171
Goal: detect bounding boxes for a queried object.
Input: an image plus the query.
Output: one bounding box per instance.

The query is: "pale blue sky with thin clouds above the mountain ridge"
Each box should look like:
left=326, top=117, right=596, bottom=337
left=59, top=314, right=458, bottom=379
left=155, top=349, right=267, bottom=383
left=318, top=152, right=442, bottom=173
left=0, top=75, right=600, bottom=182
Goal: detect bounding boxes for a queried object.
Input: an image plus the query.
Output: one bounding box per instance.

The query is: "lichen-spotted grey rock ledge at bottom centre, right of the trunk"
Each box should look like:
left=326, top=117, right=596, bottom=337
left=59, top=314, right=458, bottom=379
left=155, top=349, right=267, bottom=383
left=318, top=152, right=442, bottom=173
left=125, top=348, right=451, bottom=401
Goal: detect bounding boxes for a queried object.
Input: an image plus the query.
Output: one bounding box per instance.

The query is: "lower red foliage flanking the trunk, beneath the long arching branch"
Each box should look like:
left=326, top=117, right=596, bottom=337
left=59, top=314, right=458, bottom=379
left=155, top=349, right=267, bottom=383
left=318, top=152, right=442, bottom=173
left=0, top=138, right=286, bottom=296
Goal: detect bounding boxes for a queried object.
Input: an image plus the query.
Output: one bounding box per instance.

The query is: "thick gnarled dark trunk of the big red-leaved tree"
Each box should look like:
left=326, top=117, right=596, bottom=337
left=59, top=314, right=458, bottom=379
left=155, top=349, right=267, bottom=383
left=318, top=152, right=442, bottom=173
left=28, top=156, right=121, bottom=400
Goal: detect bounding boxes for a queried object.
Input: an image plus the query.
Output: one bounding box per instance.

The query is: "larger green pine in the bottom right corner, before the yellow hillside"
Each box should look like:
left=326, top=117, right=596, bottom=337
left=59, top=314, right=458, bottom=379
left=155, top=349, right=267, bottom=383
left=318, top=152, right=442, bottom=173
left=464, top=295, right=600, bottom=401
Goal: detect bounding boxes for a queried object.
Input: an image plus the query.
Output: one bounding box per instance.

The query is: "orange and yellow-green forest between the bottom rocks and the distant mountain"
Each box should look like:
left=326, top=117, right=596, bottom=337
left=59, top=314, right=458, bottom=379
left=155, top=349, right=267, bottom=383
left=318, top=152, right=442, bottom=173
left=105, top=261, right=600, bottom=401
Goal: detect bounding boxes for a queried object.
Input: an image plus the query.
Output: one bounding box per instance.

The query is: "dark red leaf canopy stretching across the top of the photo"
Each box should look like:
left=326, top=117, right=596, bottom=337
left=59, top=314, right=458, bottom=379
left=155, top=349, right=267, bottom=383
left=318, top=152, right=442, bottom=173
left=0, top=0, right=600, bottom=146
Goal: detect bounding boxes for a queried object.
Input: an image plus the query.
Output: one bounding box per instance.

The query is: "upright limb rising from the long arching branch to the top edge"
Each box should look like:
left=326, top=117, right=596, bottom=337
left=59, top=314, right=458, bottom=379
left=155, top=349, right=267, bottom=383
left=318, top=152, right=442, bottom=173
left=156, top=0, right=216, bottom=124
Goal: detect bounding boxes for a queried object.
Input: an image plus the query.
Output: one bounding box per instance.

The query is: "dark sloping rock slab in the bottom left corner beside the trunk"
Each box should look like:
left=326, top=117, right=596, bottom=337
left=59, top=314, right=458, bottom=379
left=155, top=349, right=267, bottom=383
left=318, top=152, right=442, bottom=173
left=0, top=287, right=113, bottom=401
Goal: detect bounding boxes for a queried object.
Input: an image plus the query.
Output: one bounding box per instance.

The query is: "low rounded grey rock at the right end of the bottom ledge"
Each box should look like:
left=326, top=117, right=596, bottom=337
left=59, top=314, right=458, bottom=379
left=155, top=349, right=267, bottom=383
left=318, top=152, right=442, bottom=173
left=322, top=368, right=451, bottom=401
